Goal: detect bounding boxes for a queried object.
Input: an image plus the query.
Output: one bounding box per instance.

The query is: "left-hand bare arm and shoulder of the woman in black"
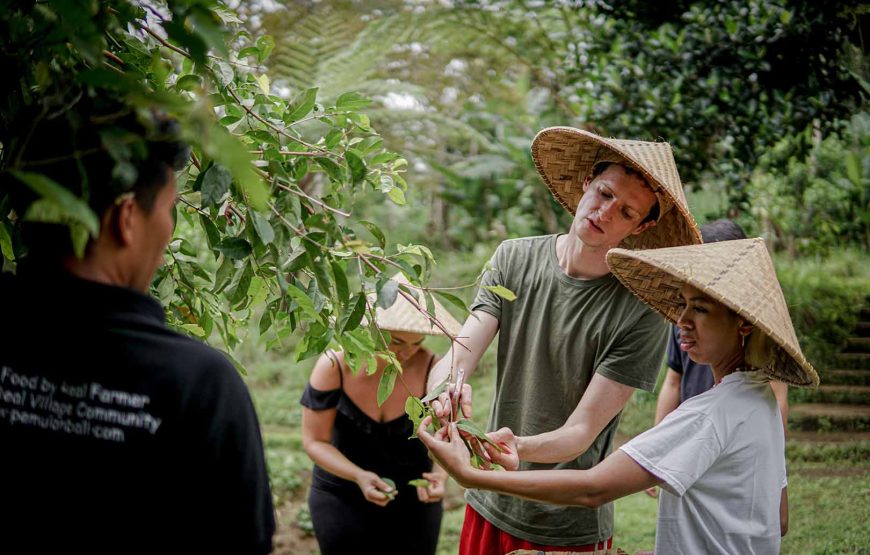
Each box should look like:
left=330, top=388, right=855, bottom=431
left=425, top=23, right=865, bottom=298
left=302, top=356, right=392, bottom=506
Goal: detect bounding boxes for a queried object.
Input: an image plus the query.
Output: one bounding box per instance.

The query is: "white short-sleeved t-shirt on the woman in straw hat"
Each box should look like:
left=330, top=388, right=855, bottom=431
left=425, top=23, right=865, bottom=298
left=621, top=372, right=787, bottom=555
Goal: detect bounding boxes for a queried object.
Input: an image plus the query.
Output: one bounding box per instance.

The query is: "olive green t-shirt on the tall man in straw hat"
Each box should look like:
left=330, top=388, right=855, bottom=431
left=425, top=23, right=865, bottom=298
left=466, top=235, right=668, bottom=545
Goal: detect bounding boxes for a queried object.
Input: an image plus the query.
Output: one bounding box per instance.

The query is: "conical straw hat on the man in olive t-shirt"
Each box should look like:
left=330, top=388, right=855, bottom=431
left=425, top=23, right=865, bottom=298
left=532, top=127, right=701, bottom=249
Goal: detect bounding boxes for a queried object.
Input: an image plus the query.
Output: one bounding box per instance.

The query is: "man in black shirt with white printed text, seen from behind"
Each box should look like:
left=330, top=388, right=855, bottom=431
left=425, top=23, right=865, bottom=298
left=0, top=98, right=275, bottom=553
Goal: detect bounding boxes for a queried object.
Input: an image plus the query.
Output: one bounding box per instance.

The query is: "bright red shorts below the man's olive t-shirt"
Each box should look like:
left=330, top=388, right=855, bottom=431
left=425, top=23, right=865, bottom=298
left=459, top=505, right=613, bottom=555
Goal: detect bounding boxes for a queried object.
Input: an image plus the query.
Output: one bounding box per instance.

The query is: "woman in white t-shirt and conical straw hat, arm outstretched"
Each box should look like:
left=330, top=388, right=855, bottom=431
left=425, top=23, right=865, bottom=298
left=418, top=239, right=819, bottom=554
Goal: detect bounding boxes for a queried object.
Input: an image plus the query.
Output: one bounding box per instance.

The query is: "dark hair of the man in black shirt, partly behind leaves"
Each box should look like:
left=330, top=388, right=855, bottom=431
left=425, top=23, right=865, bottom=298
left=0, top=95, right=190, bottom=259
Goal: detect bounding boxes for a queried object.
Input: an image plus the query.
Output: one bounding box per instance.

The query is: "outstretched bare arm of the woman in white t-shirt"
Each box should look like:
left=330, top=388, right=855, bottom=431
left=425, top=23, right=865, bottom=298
left=417, top=420, right=661, bottom=507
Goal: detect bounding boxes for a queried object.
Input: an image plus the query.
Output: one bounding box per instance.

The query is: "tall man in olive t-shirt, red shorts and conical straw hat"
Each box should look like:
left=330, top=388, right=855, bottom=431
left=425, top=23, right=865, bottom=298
left=429, top=127, right=700, bottom=555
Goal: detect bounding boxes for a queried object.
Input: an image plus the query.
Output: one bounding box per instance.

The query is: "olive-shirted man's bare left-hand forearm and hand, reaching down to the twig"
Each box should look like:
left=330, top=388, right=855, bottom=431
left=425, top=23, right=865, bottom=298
left=426, top=310, right=498, bottom=419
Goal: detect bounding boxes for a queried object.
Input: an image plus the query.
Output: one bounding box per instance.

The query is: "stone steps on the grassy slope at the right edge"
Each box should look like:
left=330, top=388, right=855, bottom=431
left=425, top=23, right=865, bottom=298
left=787, top=303, right=870, bottom=462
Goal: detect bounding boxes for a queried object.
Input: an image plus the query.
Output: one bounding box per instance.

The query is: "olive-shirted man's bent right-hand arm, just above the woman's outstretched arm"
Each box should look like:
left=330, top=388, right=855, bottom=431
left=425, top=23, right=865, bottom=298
left=508, top=374, right=634, bottom=463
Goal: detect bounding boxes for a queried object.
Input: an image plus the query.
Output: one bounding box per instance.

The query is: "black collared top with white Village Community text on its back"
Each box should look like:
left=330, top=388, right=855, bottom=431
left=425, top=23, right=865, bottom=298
left=0, top=272, right=275, bottom=553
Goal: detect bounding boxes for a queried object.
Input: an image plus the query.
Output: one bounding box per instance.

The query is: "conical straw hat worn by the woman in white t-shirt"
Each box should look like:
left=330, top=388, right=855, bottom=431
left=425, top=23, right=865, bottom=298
left=607, top=238, right=819, bottom=387
